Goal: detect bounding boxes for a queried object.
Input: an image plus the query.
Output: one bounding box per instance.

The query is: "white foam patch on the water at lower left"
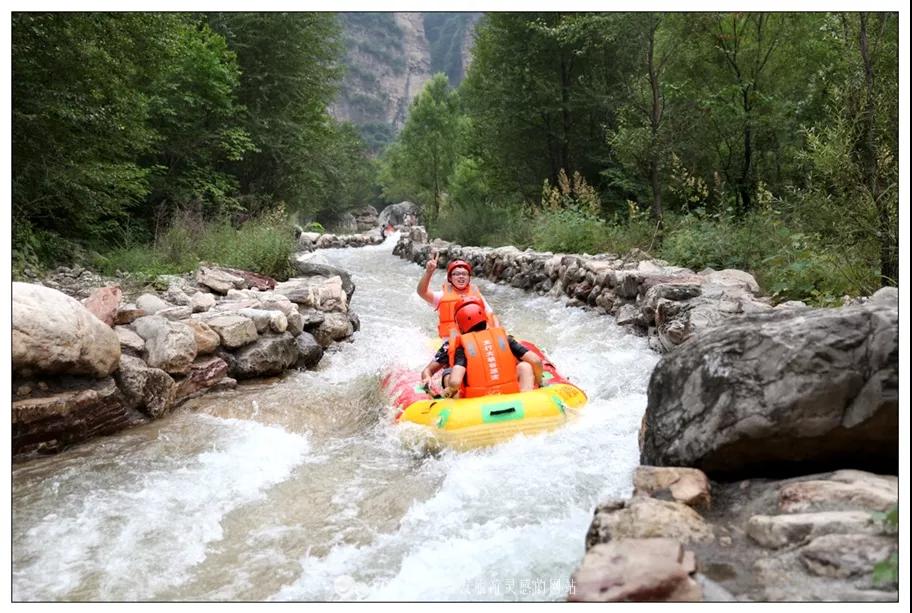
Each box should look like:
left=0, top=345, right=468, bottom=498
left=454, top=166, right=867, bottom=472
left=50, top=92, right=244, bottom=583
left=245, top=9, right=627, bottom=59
left=13, top=415, right=309, bottom=600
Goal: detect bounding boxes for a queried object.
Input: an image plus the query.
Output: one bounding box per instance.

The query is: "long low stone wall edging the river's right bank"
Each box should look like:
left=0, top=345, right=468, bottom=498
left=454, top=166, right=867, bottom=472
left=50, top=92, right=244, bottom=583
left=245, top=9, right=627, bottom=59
left=393, top=226, right=806, bottom=353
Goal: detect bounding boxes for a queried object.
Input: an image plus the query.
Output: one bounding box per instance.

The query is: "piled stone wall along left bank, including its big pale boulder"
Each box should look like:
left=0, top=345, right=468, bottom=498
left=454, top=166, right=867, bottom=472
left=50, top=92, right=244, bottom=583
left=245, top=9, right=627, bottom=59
left=12, top=261, right=360, bottom=455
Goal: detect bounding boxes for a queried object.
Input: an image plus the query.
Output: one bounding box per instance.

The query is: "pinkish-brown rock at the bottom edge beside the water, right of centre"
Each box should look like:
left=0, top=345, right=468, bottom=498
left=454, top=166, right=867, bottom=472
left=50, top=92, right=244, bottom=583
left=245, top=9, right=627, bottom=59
left=568, top=538, right=703, bottom=602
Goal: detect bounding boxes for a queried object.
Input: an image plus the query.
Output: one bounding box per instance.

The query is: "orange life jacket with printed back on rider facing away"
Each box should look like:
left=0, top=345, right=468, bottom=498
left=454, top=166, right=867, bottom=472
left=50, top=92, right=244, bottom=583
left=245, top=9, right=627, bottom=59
left=449, top=328, right=519, bottom=398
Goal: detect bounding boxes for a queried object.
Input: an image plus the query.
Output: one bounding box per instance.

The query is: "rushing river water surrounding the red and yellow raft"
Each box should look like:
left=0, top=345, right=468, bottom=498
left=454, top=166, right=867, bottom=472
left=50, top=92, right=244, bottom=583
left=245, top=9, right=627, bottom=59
left=12, top=235, right=658, bottom=601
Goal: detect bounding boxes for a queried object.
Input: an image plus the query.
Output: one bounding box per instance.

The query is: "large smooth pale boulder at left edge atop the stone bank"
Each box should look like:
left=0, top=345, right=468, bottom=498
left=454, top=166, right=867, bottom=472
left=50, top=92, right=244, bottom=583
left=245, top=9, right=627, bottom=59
left=12, top=282, right=120, bottom=378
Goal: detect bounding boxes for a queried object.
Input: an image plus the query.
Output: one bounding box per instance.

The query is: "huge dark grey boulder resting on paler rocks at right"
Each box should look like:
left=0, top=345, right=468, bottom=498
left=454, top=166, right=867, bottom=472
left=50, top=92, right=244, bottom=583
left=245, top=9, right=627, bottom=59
left=640, top=304, right=899, bottom=477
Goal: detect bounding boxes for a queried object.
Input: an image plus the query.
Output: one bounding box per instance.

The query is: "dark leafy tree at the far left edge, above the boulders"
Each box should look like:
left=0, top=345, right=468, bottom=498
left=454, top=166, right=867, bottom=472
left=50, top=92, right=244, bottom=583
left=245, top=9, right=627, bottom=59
left=12, top=13, right=165, bottom=263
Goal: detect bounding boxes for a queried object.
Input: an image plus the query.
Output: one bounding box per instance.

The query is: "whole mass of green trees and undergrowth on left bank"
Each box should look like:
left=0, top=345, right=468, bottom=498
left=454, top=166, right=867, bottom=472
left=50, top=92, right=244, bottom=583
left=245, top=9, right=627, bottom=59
left=12, top=13, right=374, bottom=272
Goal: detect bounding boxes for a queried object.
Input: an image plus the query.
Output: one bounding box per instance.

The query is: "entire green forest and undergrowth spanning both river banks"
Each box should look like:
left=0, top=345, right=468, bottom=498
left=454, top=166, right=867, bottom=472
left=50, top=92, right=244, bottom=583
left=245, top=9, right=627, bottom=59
left=11, top=12, right=900, bottom=304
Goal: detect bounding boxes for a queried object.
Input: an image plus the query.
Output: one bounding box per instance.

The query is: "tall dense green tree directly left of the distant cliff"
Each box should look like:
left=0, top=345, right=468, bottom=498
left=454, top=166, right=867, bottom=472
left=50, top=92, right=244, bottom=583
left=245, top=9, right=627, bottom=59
left=209, top=13, right=341, bottom=212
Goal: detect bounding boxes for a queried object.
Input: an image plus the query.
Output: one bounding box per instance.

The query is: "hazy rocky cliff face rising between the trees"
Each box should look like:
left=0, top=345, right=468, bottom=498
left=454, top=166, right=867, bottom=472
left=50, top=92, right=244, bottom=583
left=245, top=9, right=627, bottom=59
left=330, top=13, right=479, bottom=151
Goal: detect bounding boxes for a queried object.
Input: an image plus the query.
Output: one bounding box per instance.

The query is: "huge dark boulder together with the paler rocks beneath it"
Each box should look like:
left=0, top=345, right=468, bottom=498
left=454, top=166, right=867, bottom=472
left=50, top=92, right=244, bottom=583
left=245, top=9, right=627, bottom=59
left=569, top=288, right=899, bottom=601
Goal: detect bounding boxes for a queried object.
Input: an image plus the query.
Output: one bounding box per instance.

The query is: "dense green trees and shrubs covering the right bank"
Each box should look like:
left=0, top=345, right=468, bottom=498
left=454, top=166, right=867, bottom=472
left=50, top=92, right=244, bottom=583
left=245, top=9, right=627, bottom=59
left=380, top=13, right=899, bottom=304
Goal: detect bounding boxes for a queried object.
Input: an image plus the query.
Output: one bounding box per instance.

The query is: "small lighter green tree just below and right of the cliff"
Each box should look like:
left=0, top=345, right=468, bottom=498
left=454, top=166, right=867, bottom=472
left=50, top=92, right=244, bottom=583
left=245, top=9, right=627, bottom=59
left=380, top=73, right=458, bottom=222
